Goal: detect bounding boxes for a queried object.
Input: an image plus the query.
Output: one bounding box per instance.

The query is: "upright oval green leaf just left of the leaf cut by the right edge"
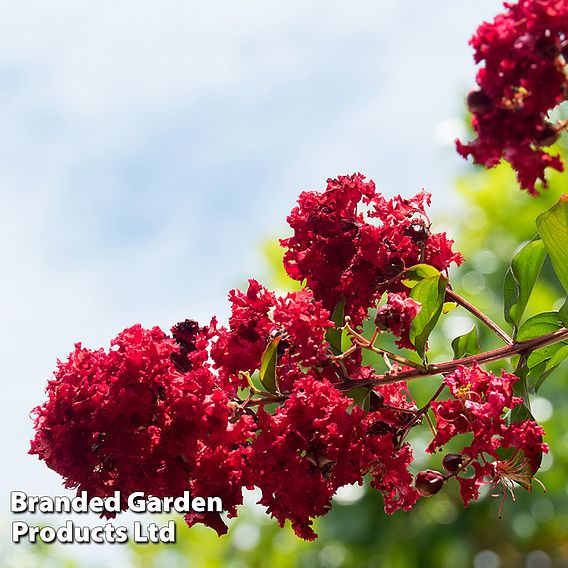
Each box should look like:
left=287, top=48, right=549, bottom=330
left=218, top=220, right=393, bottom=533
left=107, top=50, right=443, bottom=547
left=503, top=239, right=546, bottom=332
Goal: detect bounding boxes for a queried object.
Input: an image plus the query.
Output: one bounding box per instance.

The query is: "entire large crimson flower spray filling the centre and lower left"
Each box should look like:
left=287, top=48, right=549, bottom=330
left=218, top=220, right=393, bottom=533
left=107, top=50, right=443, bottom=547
left=30, top=171, right=546, bottom=540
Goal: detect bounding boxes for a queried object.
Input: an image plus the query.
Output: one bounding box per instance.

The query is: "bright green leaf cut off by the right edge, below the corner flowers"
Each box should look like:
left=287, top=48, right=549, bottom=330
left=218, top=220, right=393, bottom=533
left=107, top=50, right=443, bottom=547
left=536, top=195, right=568, bottom=292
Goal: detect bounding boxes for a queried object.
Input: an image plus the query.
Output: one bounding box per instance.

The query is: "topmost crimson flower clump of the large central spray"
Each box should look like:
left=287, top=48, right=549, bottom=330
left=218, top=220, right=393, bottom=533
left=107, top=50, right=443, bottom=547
left=280, top=174, right=462, bottom=325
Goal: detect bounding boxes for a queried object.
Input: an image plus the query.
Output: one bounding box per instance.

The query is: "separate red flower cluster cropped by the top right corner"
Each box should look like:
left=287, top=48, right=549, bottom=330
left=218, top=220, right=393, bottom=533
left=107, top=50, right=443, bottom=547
left=457, top=0, right=568, bottom=195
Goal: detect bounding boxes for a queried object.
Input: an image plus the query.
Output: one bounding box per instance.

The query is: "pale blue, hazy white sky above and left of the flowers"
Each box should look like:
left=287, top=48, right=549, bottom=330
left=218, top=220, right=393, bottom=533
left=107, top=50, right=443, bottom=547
left=0, top=0, right=500, bottom=564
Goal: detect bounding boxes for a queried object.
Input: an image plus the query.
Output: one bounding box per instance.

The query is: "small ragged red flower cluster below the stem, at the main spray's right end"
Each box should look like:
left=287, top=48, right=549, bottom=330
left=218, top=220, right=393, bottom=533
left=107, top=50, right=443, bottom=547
left=427, top=364, right=548, bottom=506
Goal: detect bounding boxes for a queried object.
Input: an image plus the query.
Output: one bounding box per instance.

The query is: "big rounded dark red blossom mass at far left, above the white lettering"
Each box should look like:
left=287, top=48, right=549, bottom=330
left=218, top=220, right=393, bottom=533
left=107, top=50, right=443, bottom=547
left=30, top=325, right=252, bottom=532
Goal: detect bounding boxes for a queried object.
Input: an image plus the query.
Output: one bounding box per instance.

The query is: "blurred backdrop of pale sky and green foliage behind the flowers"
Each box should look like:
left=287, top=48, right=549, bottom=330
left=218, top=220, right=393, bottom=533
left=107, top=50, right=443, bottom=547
left=0, top=0, right=568, bottom=568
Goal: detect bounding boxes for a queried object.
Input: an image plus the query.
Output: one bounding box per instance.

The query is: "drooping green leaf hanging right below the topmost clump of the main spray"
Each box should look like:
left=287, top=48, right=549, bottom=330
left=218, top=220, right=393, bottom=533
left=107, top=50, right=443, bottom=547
left=409, top=273, right=448, bottom=359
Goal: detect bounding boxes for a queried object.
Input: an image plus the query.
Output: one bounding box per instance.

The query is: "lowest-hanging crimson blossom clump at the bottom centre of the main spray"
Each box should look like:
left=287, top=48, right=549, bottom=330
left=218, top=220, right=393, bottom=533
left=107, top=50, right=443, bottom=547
left=251, top=377, right=373, bottom=540
